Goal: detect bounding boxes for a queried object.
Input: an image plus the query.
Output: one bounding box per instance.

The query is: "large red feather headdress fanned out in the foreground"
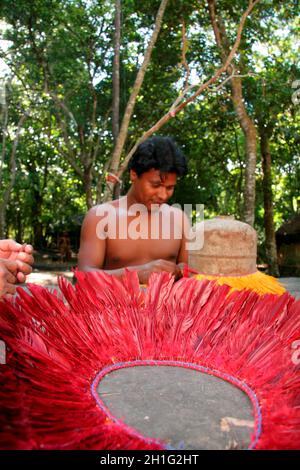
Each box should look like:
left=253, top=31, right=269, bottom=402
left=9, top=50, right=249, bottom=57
left=0, top=272, right=300, bottom=449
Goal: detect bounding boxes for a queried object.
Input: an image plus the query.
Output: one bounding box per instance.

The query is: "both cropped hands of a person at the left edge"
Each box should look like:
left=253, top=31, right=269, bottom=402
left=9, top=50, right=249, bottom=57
left=0, top=240, right=34, bottom=298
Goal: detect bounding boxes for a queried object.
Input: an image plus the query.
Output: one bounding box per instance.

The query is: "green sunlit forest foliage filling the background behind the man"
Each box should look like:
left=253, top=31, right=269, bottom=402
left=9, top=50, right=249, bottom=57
left=0, top=0, right=300, bottom=274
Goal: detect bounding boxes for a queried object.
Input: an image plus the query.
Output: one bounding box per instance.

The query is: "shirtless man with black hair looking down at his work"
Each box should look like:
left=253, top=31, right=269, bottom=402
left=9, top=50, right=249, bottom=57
left=79, top=137, right=188, bottom=284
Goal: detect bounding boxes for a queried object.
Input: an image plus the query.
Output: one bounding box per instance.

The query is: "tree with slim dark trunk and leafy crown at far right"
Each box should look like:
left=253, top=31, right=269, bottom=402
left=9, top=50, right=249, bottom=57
left=246, top=13, right=297, bottom=276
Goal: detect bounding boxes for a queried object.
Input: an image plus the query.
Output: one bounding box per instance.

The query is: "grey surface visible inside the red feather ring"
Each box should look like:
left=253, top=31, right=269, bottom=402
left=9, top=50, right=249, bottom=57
left=98, top=366, right=254, bottom=450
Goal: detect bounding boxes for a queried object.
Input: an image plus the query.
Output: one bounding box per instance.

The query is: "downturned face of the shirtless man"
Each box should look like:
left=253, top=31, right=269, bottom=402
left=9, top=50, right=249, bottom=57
left=130, top=169, right=177, bottom=210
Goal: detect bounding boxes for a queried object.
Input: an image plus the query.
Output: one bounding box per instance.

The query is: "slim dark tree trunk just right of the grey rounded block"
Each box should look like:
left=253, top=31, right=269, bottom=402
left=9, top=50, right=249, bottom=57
left=259, top=126, right=279, bottom=277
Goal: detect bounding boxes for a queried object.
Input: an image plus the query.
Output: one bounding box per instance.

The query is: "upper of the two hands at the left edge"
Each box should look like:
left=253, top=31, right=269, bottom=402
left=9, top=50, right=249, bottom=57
left=0, top=240, right=34, bottom=282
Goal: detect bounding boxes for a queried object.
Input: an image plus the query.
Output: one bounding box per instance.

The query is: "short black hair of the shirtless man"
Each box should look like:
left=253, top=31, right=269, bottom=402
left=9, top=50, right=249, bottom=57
left=128, top=136, right=187, bottom=176
